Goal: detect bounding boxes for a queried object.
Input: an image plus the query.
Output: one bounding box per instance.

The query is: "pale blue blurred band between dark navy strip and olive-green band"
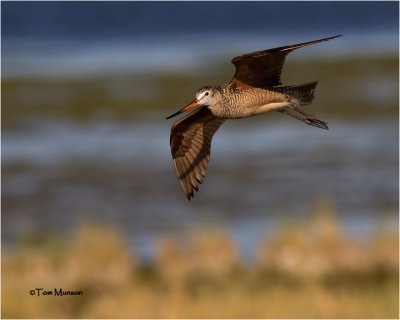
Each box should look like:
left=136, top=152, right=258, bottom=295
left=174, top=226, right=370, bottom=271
left=2, top=30, right=398, bottom=77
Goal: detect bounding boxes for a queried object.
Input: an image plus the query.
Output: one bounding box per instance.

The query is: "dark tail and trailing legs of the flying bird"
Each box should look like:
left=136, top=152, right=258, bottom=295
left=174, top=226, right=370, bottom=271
left=279, top=81, right=328, bottom=130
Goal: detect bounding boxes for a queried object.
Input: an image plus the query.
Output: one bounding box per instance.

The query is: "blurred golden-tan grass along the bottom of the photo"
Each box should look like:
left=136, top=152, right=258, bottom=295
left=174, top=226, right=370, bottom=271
left=2, top=201, right=399, bottom=318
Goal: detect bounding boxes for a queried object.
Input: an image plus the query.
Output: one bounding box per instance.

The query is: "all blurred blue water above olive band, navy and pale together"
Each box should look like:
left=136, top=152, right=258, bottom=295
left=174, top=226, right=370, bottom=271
left=2, top=2, right=398, bottom=76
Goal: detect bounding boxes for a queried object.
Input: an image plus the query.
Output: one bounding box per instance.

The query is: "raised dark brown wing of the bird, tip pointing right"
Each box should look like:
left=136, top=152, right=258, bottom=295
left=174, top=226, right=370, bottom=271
left=231, top=35, right=341, bottom=88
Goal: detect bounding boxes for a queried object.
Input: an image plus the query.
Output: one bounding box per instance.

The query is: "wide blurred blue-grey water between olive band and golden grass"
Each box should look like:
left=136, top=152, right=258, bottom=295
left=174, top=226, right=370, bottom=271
left=2, top=116, right=398, bottom=255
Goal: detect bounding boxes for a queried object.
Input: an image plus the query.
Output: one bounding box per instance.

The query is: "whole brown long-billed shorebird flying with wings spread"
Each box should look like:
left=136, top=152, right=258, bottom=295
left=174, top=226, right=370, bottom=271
left=166, top=35, right=342, bottom=200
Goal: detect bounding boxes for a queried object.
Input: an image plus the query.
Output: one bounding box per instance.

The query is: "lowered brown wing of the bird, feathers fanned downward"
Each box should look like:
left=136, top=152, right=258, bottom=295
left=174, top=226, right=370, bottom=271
left=170, top=107, right=224, bottom=200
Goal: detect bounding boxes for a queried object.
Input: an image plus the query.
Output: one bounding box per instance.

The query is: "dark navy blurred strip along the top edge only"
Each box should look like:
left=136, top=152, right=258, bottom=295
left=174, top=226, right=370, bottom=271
left=2, top=1, right=399, bottom=41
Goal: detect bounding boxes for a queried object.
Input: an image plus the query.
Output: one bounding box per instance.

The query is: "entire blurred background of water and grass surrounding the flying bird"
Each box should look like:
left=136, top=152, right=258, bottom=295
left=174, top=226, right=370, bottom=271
left=1, top=2, right=399, bottom=318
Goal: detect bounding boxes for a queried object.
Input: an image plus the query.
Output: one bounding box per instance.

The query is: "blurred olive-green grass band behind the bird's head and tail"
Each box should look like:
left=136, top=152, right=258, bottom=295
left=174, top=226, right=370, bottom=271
left=1, top=56, right=399, bottom=129
